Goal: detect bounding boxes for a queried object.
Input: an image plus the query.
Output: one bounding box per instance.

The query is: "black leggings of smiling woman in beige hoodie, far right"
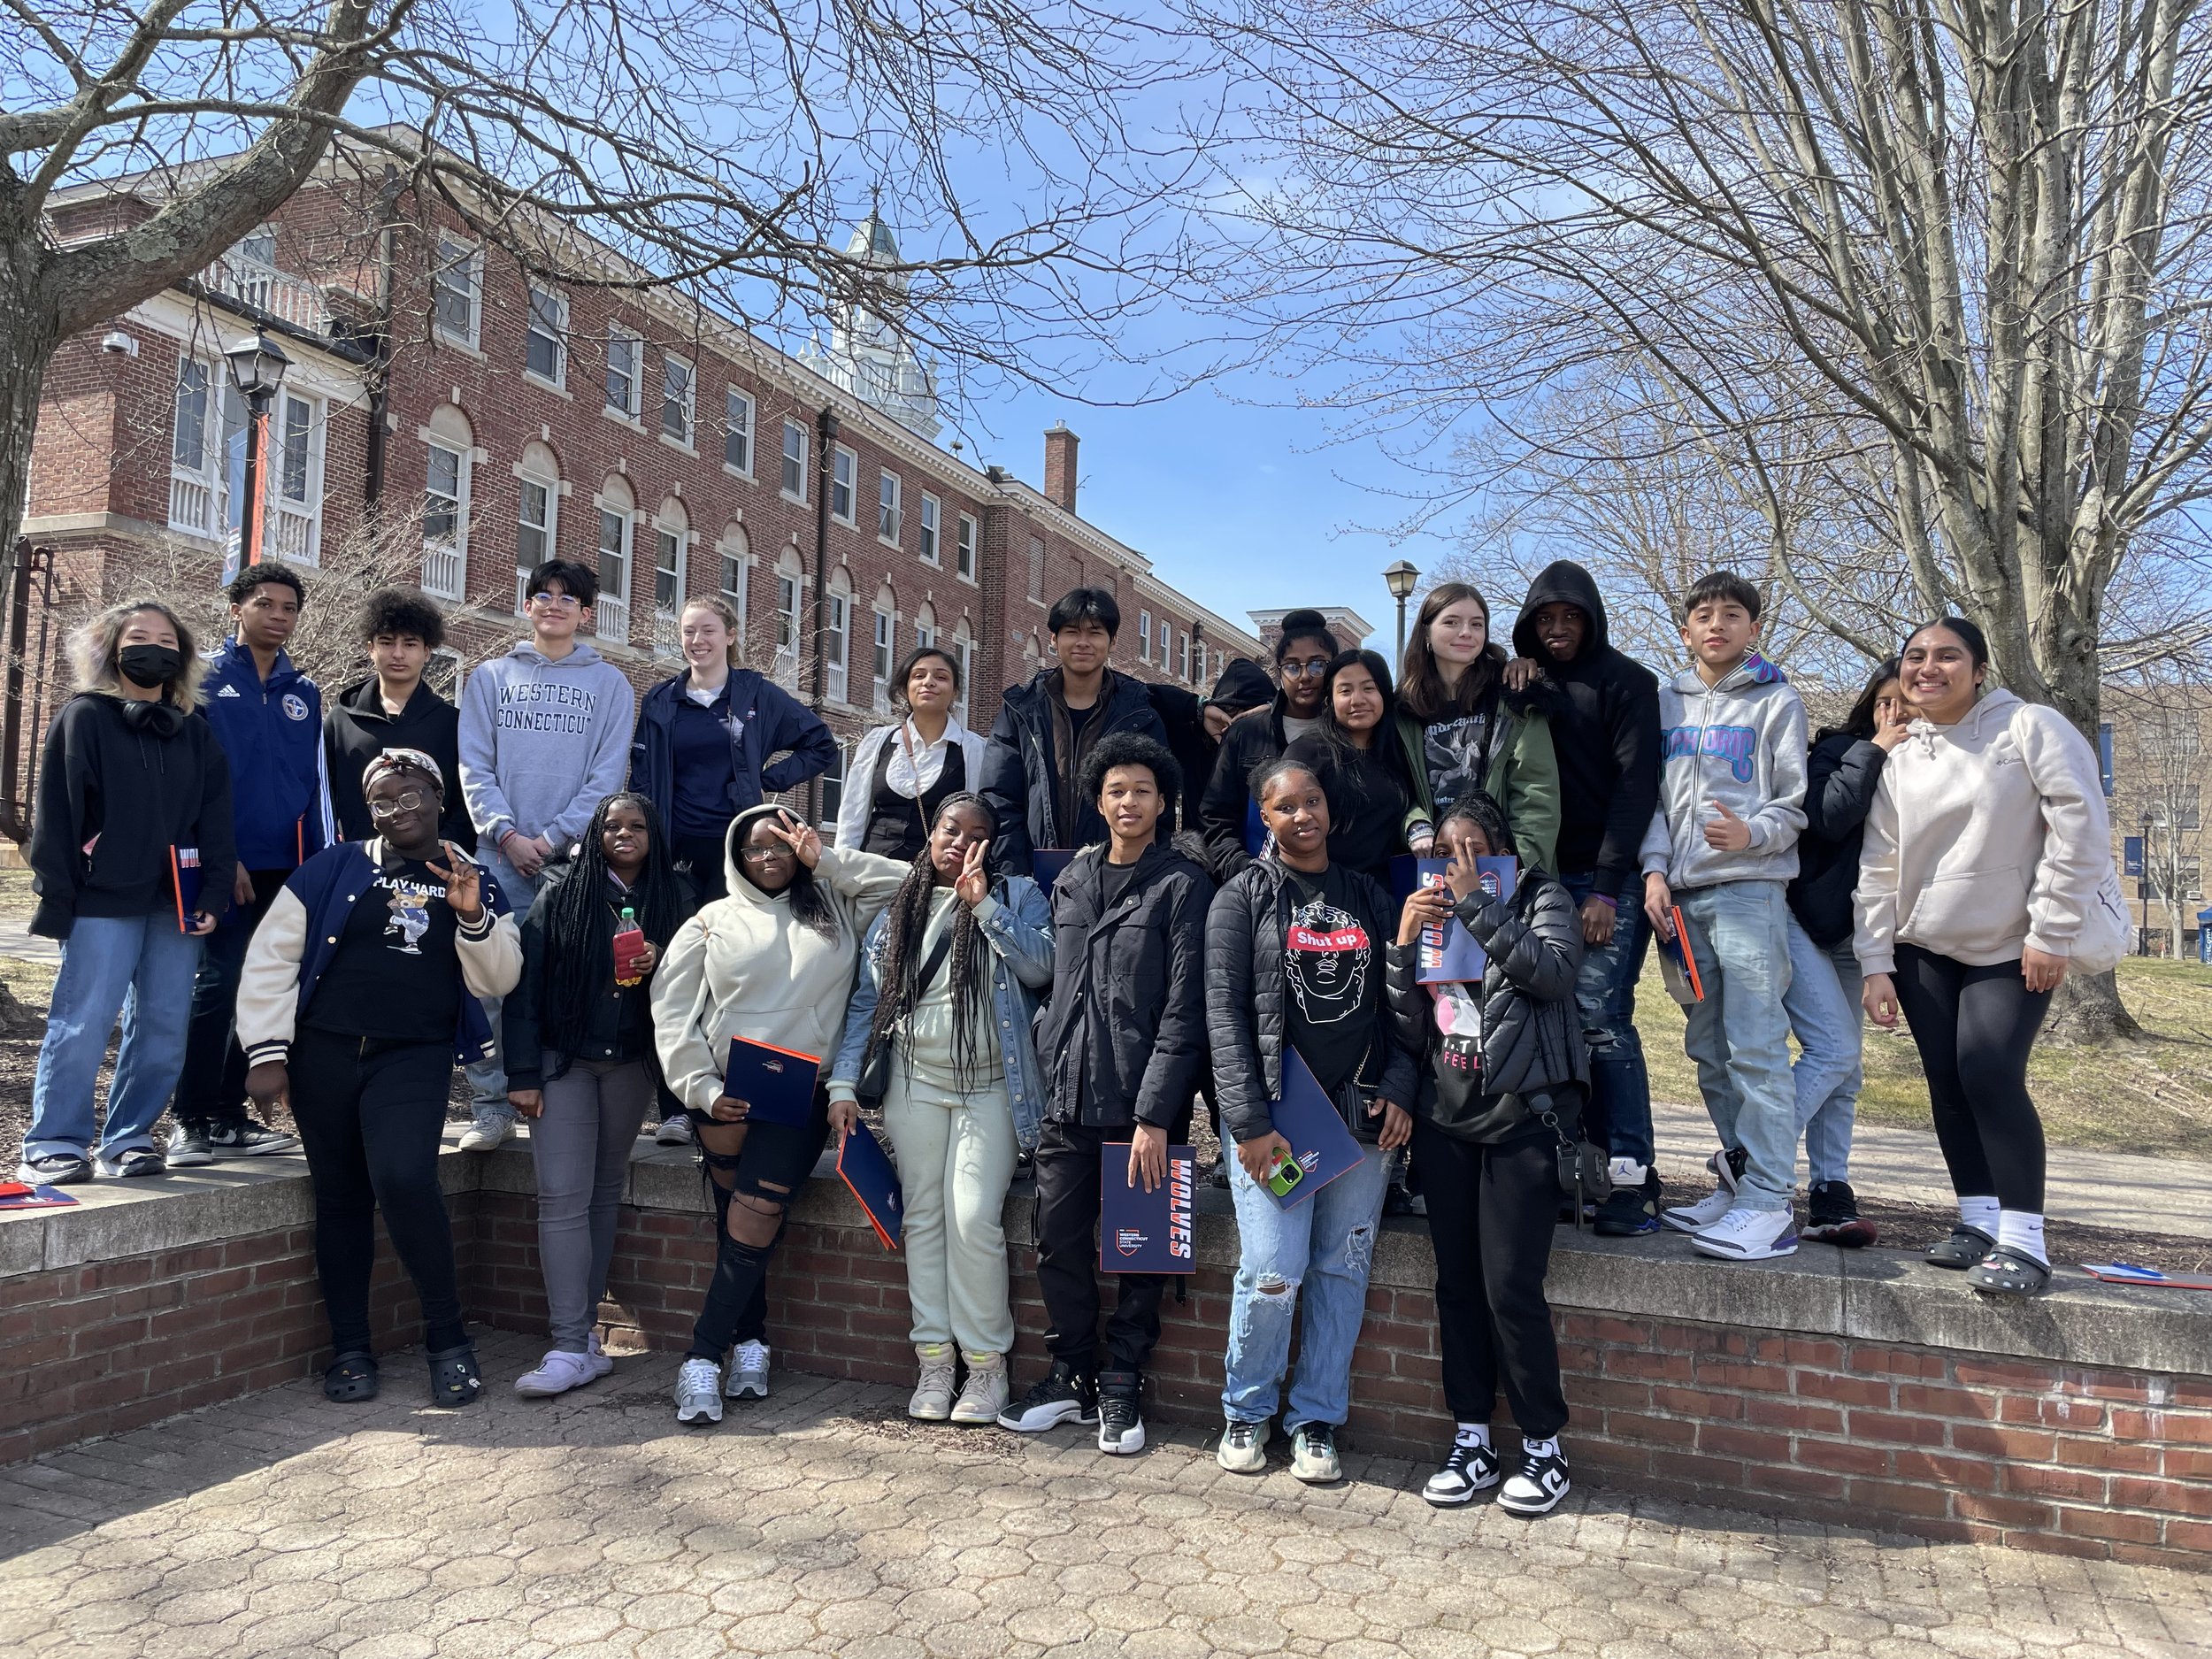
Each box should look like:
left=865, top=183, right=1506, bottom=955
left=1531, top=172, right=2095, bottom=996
left=1896, top=945, right=2051, bottom=1215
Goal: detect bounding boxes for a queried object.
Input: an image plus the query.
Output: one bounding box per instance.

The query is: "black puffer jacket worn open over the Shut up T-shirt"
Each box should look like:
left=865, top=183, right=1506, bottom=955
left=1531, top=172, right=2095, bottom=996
left=1206, top=858, right=1420, bottom=1141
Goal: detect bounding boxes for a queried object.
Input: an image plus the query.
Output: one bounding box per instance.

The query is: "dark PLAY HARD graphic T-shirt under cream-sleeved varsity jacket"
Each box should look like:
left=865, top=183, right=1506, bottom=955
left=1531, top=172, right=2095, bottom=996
left=303, top=858, right=460, bottom=1042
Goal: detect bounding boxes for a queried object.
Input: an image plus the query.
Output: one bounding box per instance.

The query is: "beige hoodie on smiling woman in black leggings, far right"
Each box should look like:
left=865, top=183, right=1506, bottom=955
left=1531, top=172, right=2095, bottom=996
left=1852, top=690, right=2113, bottom=973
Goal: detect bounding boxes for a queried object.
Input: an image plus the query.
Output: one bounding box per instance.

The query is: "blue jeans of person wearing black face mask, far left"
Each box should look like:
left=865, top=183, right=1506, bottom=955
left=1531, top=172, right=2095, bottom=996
left=22, top=911, right=199, bottom=1157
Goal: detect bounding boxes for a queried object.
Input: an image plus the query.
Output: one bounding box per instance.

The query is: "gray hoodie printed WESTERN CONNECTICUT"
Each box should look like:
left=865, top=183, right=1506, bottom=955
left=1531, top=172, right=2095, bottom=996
left=460, top=640, right=637, bottom=852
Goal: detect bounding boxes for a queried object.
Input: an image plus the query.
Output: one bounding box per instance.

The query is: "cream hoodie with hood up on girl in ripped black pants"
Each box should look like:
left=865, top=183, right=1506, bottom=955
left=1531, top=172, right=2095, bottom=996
left=653, top=805, right=911, bottom=1113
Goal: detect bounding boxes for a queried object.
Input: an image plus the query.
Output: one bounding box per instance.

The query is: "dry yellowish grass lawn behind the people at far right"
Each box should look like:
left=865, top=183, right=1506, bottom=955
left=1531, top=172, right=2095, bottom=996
left=1637, top=954, right=2212, bottom=1162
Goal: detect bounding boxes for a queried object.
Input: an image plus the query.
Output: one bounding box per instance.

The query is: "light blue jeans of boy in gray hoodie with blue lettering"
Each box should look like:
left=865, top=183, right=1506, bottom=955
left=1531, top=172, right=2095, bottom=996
left=1675, top=880, right=1796, bottom=1210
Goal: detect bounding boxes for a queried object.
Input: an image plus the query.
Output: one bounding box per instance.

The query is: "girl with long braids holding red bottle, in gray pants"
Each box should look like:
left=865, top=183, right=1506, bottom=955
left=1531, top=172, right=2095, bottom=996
left=500, top=790, right=699, bottom=1398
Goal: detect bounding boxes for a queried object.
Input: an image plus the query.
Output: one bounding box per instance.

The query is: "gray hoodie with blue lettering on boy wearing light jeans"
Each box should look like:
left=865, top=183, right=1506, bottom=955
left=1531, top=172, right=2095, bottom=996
left=1641, top=650, right=1805, bottom=889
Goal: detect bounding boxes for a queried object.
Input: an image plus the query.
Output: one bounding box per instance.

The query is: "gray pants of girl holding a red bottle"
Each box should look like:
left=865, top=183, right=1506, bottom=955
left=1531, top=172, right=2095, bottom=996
left=529, top=1060, right=653, bottom=1354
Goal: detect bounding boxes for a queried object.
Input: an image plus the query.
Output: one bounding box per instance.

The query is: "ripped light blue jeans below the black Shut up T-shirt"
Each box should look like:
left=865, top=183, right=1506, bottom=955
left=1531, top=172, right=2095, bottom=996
left=1221, top=1146, right=1389, bottom=1427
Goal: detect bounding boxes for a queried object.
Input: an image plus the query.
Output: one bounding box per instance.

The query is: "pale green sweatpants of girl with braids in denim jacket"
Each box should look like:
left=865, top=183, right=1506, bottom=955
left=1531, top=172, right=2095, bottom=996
left=883, top=1053, right=1020, bottom=1354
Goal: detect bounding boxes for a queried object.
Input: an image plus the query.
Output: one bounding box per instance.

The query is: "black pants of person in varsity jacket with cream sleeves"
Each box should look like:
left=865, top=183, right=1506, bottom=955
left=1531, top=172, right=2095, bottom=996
left=290, top=1029, right=467, bottom=1354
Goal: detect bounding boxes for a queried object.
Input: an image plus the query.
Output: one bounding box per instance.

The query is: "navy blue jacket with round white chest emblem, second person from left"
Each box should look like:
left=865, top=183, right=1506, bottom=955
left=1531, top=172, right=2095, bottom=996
left=199, top=640, right=339, bottom=870
